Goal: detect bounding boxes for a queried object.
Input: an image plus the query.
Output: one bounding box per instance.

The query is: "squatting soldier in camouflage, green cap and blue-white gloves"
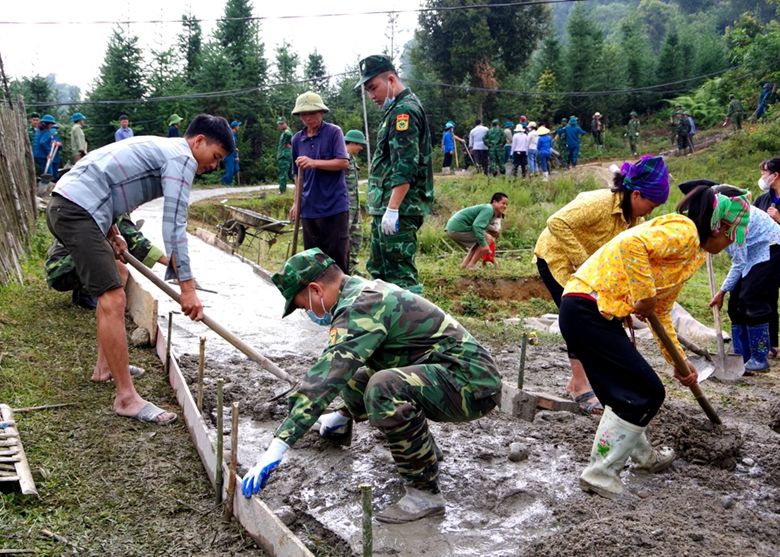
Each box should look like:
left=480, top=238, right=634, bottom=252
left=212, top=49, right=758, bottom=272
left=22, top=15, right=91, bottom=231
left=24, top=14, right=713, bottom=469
left=242, top=248, right=501, bottom=523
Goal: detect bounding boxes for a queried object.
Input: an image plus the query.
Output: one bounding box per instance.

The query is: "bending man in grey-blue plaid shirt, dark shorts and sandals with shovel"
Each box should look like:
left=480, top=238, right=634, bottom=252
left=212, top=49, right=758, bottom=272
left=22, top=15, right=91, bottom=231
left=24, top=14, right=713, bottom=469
left=46, top=114, right=234, bottom=424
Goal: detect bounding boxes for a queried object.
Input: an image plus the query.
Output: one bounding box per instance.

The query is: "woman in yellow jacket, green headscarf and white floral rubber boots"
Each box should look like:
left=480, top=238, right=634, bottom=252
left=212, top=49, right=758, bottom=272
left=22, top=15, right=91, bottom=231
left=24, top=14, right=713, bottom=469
left=560, top=185, right=750, bottom=497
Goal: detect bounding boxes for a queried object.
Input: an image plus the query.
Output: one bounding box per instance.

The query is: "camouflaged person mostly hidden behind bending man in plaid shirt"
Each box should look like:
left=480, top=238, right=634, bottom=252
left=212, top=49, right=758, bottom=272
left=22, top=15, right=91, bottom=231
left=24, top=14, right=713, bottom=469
left=44, top=213, right=168, bottom=309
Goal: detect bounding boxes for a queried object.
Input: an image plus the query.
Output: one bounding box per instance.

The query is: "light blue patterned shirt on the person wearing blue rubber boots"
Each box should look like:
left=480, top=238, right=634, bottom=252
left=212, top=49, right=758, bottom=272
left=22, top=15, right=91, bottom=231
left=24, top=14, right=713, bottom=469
left=720, top=206, right=780, bottom=292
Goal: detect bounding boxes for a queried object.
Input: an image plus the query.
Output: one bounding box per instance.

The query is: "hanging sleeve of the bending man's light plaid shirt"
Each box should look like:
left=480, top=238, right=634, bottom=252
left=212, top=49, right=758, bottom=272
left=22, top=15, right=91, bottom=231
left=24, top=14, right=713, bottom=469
left=160, top=157, right=197, bottom=281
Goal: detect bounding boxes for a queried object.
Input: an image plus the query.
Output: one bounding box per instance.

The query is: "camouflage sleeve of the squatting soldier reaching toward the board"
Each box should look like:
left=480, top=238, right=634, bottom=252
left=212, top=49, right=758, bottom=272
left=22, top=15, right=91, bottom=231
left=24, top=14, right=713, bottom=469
left=274, top=294, right=387, bottom=446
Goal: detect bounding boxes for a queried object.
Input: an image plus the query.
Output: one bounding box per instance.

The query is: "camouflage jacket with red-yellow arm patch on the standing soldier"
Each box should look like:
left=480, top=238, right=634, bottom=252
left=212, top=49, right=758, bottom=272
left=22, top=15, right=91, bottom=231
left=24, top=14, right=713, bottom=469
left=367, top=89, right=433, bottom=216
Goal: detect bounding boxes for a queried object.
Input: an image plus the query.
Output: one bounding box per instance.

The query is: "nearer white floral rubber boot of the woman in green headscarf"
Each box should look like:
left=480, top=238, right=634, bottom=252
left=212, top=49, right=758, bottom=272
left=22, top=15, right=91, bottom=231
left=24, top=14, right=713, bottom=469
left=580, top=406, right=645, bottom=499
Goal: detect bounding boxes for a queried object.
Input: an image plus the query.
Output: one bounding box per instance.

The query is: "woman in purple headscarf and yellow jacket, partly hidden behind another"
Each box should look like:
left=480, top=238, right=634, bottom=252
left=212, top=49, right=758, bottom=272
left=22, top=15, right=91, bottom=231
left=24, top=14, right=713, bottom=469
left=534, top=156, right=669, bottom=414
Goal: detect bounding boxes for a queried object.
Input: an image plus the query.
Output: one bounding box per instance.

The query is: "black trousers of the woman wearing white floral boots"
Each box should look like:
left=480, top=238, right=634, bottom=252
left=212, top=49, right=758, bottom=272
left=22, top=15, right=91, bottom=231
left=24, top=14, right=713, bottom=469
left=558, top=295, right=666, bottom=427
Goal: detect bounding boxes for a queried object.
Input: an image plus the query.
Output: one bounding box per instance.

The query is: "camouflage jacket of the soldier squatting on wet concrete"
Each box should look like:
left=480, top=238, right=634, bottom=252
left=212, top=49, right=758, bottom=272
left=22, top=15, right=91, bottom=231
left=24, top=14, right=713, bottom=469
left=275, top=276, right=501, bottom=445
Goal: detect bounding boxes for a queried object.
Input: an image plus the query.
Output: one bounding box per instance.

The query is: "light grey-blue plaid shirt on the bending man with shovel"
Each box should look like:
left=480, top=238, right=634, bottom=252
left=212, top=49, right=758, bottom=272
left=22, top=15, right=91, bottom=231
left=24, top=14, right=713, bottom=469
left=54, top=136, right=198, bottom=280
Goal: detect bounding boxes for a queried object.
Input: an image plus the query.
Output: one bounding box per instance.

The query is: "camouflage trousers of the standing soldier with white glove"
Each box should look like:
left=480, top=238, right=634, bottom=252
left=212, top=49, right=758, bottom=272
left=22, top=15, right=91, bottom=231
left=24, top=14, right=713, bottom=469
left=366, top=215, right=423, bottom=294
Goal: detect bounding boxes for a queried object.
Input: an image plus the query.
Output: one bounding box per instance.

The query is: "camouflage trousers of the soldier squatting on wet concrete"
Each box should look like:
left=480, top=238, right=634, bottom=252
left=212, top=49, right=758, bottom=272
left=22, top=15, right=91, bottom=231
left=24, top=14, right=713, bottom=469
left=341, top=364, right=500, bottom=493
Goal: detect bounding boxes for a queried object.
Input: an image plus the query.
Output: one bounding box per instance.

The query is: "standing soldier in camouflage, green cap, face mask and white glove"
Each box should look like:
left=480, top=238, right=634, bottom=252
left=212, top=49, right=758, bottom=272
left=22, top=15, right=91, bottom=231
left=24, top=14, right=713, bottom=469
left=355, top=54, right=433, bottom=294
